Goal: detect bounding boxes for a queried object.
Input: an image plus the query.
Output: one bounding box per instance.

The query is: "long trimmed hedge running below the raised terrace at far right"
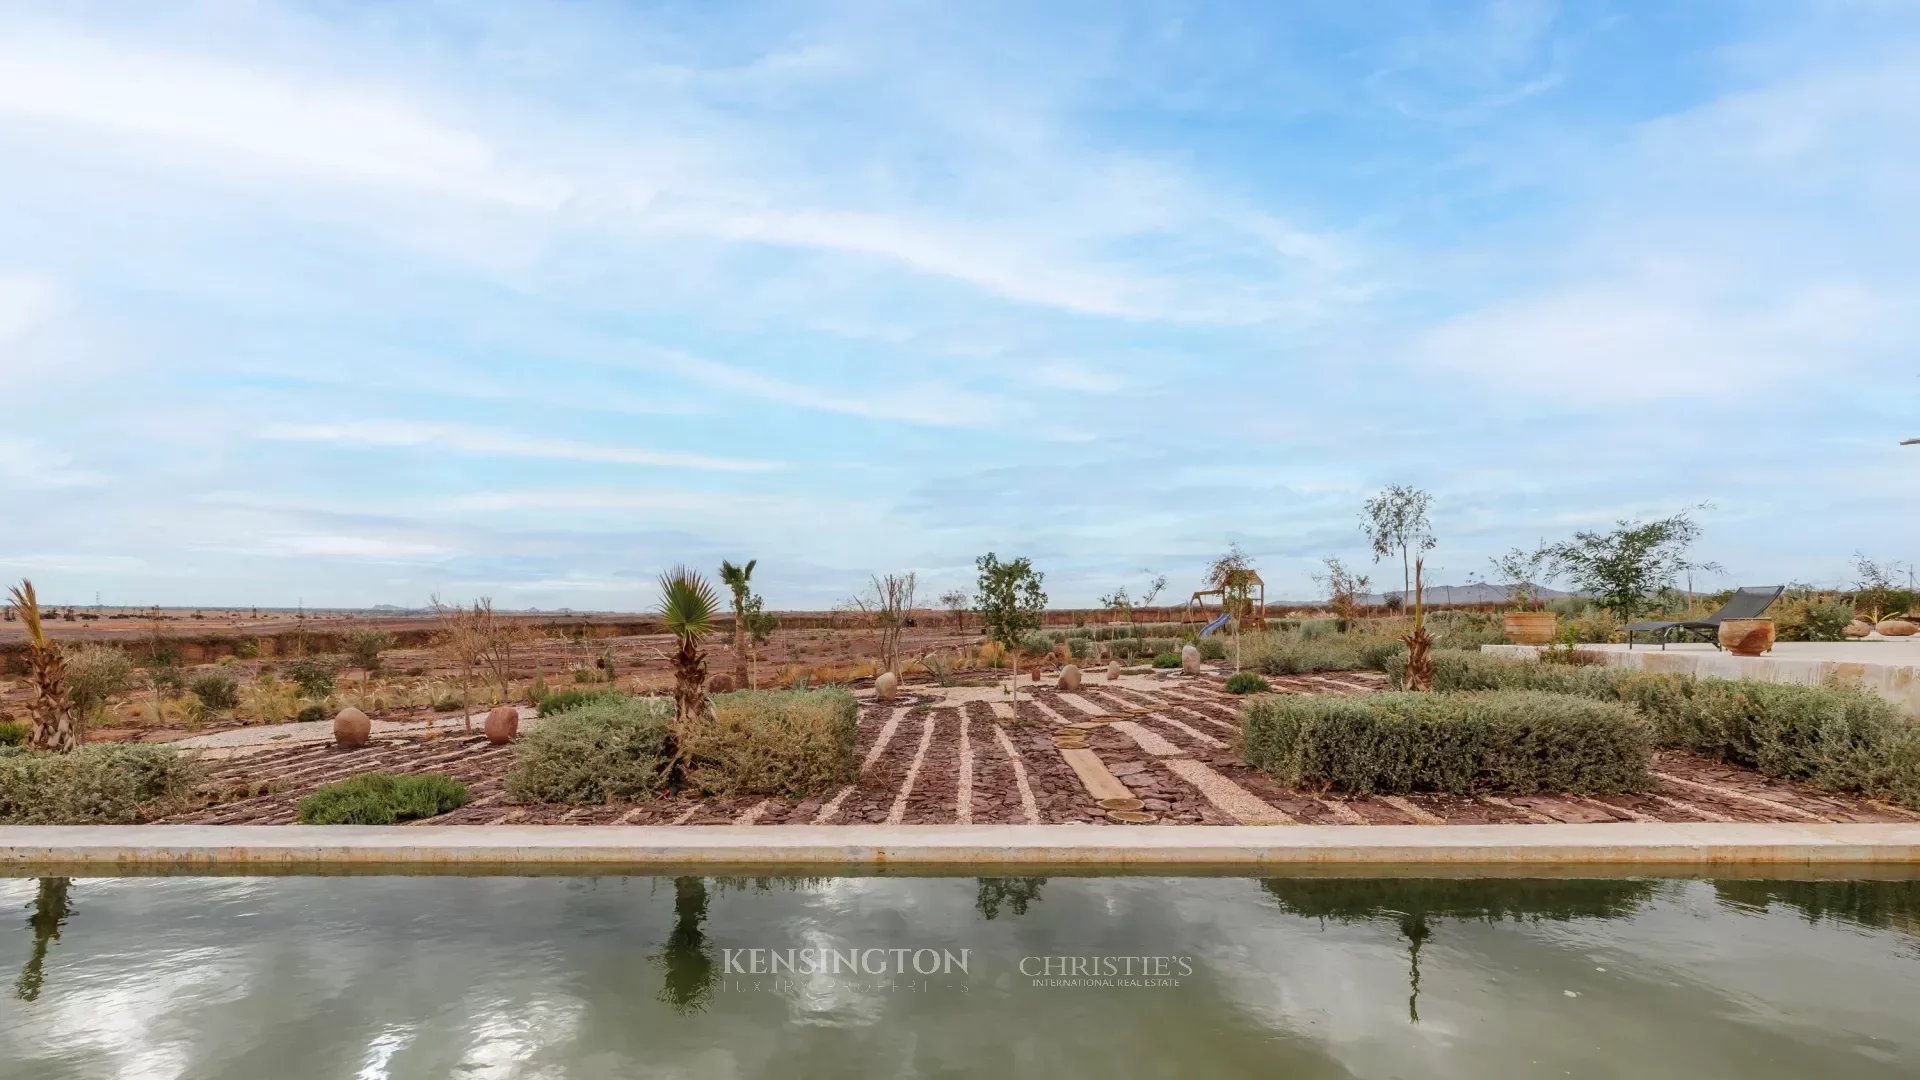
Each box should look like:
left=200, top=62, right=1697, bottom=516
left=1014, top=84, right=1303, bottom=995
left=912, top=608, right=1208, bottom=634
left=1388, top=653, right=1920, bottom=809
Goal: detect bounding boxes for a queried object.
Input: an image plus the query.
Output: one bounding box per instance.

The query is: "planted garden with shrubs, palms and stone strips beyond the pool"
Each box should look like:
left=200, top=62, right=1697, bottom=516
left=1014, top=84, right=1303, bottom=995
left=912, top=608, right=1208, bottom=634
left=0, top=488, right=1920, bottom=824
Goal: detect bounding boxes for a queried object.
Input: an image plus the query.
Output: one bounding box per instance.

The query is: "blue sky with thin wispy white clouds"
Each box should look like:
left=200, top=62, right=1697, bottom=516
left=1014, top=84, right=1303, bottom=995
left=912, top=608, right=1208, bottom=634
left=0, top=0, right=1920, bottom=609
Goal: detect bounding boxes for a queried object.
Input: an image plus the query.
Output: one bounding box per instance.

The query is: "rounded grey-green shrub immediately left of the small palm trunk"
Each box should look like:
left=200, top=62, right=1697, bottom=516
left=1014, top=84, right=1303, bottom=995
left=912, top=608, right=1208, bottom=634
left=505, top=698, right=674, bottom=803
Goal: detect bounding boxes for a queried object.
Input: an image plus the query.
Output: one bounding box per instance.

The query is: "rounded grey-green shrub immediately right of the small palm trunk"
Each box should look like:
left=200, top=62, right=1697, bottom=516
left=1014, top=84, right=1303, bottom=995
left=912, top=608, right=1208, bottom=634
left=680, top=690, right=860, bottom=796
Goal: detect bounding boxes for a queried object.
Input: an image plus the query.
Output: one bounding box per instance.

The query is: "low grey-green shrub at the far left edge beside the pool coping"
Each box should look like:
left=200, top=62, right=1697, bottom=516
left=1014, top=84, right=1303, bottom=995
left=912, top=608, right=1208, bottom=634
left=0, top=744, right=202, bottom=824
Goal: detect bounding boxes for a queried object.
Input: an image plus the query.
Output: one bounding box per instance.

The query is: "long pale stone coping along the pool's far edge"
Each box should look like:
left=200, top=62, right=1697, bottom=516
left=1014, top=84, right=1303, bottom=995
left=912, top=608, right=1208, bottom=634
left=0, top=822, right=1920, bottom=871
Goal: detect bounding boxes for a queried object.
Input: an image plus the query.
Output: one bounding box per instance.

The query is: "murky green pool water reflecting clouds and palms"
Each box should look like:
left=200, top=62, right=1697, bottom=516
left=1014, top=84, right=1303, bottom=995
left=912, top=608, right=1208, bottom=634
left=0, top=876, right=1920, bottom=1080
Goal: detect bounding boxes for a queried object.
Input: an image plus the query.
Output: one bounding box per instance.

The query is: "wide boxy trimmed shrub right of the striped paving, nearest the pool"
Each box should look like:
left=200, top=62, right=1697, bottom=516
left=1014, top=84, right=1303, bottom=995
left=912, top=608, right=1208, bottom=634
left=1240, top=692, right=1653, bottom=796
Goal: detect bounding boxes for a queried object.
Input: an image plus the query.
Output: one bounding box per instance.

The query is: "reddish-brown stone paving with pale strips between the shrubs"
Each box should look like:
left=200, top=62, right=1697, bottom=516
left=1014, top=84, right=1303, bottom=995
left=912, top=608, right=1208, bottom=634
left=157, top=673, right=1920, bottom=826
